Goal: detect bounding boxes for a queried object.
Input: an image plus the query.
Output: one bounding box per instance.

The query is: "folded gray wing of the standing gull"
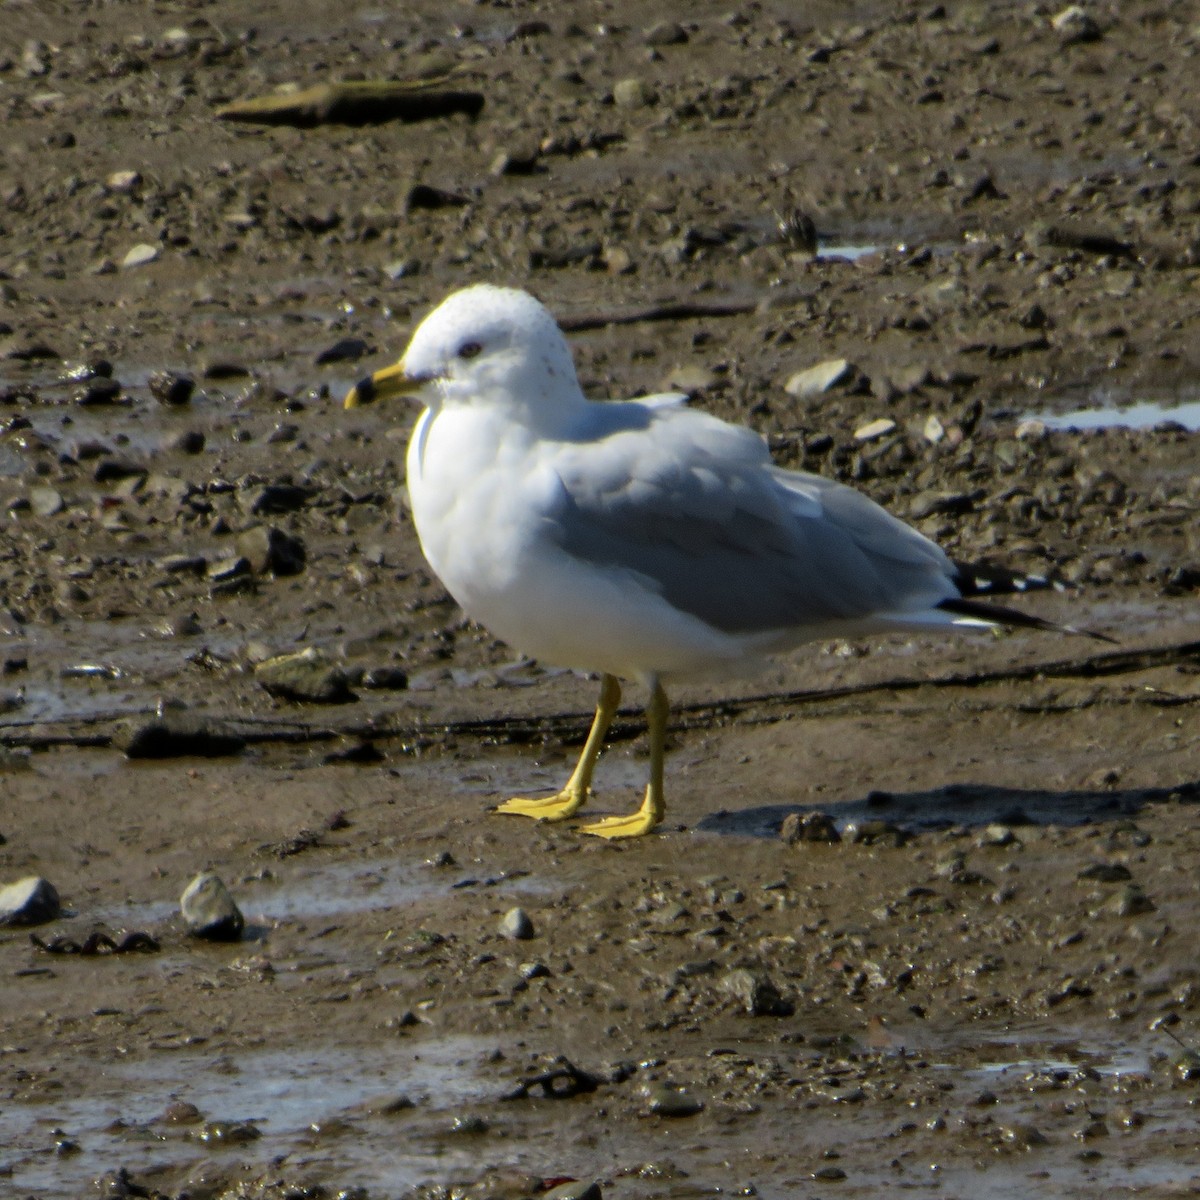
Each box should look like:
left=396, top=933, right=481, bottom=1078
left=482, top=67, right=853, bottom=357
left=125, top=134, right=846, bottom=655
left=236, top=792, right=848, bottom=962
left=551, top=404, right=958, bottom=634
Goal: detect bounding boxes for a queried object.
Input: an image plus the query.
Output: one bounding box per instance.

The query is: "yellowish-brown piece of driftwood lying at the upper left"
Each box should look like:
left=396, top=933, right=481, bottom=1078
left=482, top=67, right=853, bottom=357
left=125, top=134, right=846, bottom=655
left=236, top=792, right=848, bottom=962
left=217, top=79, right=484, bottom=128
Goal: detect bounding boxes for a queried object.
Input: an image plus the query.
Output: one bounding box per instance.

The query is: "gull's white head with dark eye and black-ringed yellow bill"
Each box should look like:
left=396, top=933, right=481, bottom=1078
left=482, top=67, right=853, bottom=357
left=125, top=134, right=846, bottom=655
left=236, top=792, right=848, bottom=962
left=346, top=283, right=583, bottom=425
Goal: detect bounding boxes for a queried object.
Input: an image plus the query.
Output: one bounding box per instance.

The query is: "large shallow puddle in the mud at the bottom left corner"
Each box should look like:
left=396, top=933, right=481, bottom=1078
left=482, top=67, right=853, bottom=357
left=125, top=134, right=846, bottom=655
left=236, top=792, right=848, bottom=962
left=0, top=1036, right=503, bottom=1198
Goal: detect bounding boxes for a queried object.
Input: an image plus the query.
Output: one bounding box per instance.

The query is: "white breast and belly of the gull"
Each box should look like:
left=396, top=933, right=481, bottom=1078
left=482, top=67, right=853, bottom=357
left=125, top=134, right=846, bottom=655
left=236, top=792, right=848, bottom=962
left=408, top=409, right=754, bottom=680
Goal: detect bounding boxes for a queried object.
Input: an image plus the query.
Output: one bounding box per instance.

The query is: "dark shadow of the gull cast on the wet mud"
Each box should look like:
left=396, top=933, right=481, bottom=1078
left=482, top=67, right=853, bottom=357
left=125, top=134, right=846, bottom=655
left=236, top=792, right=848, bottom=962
left=695, top=780, right=1200, bottom=838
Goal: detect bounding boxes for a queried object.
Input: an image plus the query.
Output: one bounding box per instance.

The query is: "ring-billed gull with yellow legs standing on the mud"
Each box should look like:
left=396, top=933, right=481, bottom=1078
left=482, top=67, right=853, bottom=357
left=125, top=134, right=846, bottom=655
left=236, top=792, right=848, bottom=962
left=346, top=284, right=1099, bottom=838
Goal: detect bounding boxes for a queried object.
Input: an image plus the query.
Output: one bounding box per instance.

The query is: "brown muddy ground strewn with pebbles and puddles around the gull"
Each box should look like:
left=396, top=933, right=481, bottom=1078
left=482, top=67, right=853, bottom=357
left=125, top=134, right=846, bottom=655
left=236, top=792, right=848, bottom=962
left=0, top=0, right=1200, bottom=1200
